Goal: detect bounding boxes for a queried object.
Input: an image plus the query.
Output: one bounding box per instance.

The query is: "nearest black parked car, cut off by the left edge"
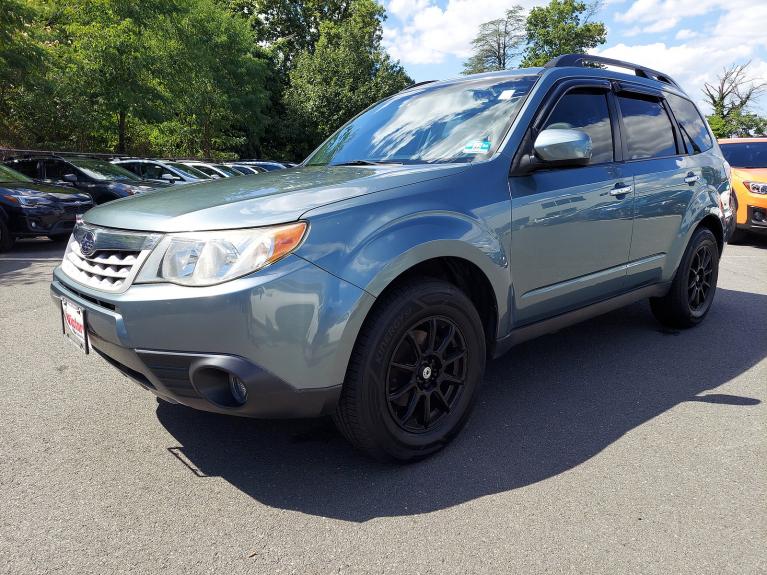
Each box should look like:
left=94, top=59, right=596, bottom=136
left=0, top=165, right=93, bottom=251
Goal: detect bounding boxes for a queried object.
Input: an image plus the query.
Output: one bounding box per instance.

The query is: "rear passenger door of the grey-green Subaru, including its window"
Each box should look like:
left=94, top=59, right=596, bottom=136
left=616, top=85, right=702, bottom=288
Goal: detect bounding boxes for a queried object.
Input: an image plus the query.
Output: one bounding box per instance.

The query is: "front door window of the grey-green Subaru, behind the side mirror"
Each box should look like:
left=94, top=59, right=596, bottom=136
left=543, top=90, right=614, bottom=164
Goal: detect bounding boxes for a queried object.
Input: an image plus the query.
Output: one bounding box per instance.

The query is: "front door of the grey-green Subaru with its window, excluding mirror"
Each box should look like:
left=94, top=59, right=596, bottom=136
left=510, top=81, right=634, bottom=326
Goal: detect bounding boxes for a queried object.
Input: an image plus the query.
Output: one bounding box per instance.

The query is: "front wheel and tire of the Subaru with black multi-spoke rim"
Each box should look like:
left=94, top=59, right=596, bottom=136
left=333, top=279, right=486, bottom=462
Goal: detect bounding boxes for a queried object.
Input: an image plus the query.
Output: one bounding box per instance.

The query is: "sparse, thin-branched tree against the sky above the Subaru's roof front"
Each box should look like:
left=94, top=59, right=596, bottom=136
left=463, top=6, right=525, bottom=74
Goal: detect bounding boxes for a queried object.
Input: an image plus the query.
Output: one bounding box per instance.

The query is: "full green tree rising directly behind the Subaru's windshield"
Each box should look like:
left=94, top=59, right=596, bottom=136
left=285, top=0, right=412, bottom=155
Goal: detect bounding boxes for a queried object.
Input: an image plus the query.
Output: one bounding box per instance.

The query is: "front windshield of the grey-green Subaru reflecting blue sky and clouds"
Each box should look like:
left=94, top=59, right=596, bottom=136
left=306, top=76, right=537, bottom=165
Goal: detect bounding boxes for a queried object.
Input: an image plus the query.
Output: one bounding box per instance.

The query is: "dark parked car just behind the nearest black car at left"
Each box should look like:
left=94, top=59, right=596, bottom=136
left=5, top=155, right=169, bottom=204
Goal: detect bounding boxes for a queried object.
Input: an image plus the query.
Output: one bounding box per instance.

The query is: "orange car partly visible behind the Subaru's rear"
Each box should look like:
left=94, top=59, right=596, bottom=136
left=719, top=138, right=767, bottom=241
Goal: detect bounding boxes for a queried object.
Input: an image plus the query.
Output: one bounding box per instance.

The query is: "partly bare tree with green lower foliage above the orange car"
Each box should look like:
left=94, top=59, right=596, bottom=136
left=703, top=62, right=767, bottom=138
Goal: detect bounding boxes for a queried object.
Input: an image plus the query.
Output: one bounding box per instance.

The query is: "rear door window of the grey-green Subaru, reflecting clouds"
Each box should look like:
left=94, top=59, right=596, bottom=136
left=618, top=95, right=677, bottom=160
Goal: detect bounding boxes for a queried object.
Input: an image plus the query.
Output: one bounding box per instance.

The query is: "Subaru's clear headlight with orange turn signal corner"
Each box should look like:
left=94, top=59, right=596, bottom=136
left=136, top=222, right=307, bottom=286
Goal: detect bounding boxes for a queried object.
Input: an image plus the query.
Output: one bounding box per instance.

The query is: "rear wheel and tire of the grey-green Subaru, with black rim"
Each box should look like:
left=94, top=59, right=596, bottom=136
left=650, top=228, right=719, bottom=329
